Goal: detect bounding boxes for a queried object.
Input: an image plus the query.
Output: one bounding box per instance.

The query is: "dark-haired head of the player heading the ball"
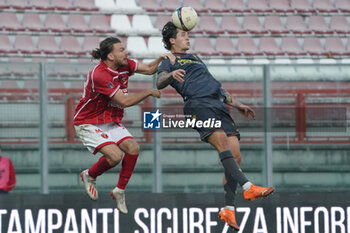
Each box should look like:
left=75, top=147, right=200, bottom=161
left=162, top=21, right=190, bottom=53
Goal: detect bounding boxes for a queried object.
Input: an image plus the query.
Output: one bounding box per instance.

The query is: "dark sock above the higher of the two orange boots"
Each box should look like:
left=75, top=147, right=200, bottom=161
left=219, top=150, right=248, bottom=186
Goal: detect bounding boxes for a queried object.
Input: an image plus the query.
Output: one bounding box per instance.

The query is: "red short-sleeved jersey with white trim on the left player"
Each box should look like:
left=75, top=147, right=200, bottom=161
left=74, top=59, right=137, bottom=125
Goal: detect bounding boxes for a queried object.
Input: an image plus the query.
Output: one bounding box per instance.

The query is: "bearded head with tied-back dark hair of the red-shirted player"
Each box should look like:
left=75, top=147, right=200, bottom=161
left=91, top=37, right=128, bottom=67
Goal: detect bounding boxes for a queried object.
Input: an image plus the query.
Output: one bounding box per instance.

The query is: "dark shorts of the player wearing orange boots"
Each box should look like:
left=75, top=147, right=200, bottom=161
left=184, top=97, right=240, bottom=142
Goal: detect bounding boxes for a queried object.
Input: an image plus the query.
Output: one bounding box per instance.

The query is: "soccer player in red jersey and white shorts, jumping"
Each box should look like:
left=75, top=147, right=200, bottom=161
left=74, top=37, right=175, bottom=214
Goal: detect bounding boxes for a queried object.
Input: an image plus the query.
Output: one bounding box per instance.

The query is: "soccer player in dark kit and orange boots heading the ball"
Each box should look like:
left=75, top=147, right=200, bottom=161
left=157, top=22, right=274, bottom=230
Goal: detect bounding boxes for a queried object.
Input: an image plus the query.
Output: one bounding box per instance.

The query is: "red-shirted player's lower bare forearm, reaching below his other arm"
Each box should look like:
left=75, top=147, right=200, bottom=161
left=112, top=89, right=160, bottom=108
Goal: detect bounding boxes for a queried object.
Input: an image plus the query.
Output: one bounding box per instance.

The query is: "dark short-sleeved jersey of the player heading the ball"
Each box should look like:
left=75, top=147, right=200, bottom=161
left=158, top=53, right=221, bottom=101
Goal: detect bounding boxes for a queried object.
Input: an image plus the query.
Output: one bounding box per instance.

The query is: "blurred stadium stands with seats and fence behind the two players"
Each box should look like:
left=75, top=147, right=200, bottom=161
left=0, top=0, right=350, bottom=231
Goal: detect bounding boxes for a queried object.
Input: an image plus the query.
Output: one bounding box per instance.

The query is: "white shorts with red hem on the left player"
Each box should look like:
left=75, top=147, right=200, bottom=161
left=74, top=123, right=134, bottom=154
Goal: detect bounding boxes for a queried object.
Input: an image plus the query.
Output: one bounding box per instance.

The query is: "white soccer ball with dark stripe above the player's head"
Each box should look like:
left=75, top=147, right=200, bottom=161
left=171, top=6, right=198, bottom=31
